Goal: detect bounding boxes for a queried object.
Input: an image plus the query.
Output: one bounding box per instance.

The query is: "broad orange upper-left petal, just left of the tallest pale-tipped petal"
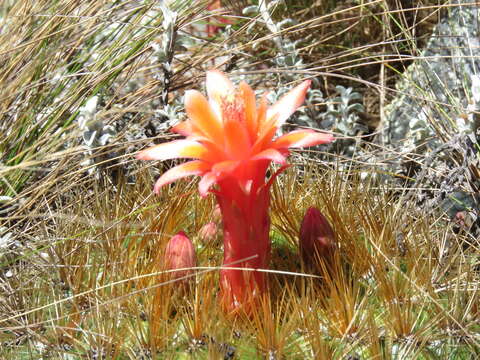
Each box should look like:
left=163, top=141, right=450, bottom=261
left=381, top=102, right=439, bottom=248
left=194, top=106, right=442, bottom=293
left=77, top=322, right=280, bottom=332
left=185, top=90, right=223, bottom=143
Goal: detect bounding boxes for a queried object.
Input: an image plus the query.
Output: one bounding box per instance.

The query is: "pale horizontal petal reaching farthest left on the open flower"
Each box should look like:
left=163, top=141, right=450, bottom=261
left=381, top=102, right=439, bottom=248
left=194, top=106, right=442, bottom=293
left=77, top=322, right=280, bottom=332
left=137, top=140, right=208, bottom=160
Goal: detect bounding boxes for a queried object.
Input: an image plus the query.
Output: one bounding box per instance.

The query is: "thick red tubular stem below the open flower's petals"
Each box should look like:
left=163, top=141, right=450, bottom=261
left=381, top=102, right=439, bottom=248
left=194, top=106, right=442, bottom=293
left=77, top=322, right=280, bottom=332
left=217, top=180, right=270, bottom=312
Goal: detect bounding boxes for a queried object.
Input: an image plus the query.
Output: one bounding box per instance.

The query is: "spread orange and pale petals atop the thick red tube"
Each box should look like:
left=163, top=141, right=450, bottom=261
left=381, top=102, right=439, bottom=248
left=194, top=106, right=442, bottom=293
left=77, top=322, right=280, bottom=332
left=137, top=70, right=333, bottom=196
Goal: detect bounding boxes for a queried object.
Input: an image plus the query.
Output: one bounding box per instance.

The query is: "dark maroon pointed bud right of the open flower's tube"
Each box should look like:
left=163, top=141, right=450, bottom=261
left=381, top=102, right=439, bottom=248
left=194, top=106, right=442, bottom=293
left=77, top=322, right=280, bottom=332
left=300, top=206, right=335, bottom=263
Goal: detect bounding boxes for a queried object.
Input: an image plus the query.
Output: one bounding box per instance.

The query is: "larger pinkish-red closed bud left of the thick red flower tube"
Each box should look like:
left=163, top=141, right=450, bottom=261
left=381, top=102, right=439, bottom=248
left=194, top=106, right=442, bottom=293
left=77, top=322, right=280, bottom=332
left=165, top=231, right=197, bottom=279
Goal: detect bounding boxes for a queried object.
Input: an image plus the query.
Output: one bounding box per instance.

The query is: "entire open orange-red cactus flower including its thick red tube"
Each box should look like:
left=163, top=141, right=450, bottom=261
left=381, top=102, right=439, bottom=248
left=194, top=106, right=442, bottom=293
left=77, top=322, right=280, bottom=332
left=137, top=70, right=333, bottom=311
